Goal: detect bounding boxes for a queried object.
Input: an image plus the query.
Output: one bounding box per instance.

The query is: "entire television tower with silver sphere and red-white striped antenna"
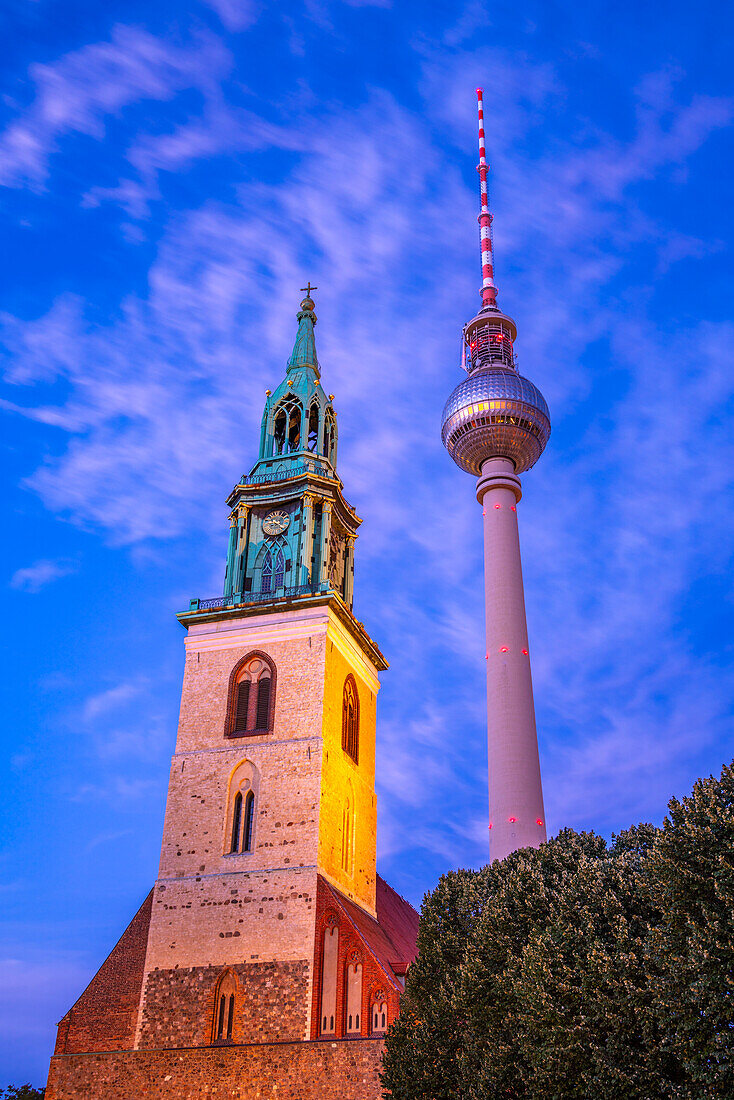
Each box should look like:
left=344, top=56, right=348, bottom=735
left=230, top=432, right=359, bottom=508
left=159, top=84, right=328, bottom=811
left=441, top=88, right=550, bottom=859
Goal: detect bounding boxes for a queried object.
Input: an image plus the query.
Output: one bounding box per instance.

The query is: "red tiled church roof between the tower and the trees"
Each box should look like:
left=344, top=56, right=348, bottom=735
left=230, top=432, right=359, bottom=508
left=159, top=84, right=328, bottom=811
left=322, top=875, right=419, bottom=977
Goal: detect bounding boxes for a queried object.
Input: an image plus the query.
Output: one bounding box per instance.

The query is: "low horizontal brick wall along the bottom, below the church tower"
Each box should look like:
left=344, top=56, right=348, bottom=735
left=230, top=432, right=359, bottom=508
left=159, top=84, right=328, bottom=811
left=46, top=1040, right=383, bottom=1100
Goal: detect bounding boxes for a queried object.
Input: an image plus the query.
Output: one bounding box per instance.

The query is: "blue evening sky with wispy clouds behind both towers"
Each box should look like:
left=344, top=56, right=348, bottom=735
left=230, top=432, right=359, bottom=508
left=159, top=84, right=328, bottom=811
left=0, top=0, right=734, bottom=1086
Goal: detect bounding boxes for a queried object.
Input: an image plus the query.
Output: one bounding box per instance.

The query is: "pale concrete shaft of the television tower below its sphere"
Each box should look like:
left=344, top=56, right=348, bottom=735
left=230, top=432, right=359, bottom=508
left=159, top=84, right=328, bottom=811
left=476, top=458, right=546, bottom=859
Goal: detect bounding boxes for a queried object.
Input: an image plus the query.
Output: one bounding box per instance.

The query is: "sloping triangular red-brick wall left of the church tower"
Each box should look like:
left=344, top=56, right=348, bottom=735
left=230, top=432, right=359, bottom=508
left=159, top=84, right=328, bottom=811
left=56, top=890, right=153, bottom=1054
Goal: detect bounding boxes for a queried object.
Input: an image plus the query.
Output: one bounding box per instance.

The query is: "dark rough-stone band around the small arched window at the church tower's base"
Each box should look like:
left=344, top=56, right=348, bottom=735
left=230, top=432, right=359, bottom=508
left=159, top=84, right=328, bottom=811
left=139, top=960, right=309, bottom=1049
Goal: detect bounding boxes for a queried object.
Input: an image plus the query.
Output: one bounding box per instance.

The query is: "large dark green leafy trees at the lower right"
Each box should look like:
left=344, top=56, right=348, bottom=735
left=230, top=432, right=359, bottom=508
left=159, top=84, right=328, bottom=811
left=383, top=768, right=734, bottom=1100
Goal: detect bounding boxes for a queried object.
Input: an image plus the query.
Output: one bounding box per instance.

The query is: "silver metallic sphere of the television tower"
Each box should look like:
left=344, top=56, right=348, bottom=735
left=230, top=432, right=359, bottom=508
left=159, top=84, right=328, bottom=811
left=441, top=366, right=550, bottom=476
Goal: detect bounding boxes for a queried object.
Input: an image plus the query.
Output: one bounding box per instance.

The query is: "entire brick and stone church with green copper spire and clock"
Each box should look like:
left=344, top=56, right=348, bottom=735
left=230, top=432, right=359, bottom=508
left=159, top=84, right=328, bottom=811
left=47, top=285, right=417, bottom=1100
